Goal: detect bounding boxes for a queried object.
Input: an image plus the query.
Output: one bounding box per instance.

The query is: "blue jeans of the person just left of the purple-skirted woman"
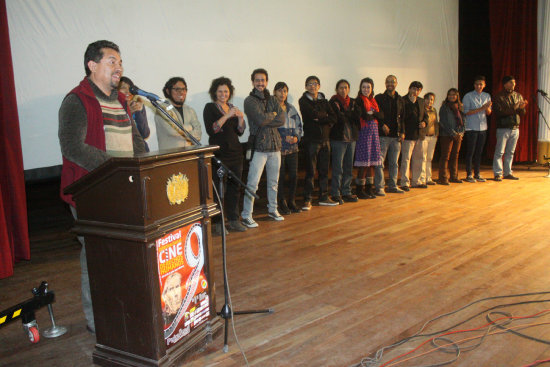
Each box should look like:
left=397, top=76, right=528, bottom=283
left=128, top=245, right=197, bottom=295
left=330, top=140, right=355, bottom=197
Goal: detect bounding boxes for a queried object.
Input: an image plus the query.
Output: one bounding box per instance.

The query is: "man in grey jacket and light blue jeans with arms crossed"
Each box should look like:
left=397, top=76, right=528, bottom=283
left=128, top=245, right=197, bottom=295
left=241, top=69, right=285, bottom=228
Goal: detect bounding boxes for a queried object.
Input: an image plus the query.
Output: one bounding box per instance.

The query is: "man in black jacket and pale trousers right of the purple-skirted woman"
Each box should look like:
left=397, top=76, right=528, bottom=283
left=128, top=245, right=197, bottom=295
left=374, top=75, right=404, bottom=196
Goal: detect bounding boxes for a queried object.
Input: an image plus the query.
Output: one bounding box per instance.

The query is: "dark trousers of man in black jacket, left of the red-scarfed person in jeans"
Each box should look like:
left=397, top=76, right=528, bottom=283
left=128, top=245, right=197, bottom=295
left=304, top=141, right=330, bottom=201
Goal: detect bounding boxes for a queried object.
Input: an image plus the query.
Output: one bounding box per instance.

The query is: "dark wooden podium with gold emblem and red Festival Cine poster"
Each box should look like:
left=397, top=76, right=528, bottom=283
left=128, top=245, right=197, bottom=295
left=65, top=146, right=222, bottom=366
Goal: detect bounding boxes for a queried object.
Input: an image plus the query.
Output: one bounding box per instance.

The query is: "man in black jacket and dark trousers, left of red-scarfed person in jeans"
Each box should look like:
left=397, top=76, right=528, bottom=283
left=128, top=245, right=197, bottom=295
left=299, top=76, right=339, bottom=210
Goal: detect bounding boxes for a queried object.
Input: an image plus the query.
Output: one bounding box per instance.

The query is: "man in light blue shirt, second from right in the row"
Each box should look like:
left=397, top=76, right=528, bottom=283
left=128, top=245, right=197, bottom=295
left=462, top=75, right=492, bottom=183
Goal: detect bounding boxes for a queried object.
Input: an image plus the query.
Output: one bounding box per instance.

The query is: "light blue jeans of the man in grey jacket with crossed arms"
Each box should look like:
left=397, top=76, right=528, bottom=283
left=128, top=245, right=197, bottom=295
left=241, top=152, right=281, bottom=218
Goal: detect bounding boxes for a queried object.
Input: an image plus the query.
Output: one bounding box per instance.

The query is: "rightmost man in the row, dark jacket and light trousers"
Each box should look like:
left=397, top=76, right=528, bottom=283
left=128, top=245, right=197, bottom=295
left=493, top=75, right=527, bottom=181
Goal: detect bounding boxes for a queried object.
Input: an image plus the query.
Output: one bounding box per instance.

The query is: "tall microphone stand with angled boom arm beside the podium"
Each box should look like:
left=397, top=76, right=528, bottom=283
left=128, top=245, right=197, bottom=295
left=147, top=96, right=275, bottom=353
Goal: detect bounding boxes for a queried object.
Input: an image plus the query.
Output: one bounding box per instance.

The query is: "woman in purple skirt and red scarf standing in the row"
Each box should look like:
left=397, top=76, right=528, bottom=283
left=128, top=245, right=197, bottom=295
left=354, top=78, right=382, bottom=199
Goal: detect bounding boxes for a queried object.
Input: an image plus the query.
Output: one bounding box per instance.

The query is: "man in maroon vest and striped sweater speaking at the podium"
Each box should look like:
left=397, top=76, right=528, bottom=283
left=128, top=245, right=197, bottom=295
left=58, top=41, right=145, bottom=333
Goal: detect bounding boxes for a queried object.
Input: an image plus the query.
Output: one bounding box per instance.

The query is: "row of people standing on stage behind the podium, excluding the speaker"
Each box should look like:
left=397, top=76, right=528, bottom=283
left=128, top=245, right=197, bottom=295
left=120, top=69, right=527, bottom=233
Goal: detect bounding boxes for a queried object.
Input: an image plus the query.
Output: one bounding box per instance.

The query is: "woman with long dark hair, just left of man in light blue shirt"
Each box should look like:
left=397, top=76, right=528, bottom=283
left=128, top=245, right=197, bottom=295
left=437, top=88, right=464, bottom=185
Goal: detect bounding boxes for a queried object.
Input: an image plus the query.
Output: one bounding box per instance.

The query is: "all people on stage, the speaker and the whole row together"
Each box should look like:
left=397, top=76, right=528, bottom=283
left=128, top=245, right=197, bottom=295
left=58, top=40, right=527, bottom=333
